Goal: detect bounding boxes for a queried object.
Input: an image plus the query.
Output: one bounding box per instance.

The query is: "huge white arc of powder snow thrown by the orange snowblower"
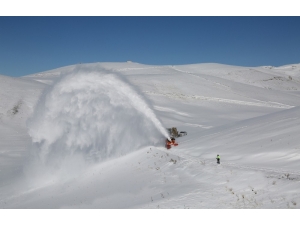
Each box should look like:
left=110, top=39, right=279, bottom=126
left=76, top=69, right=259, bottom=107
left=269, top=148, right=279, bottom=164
left=27, top=65, right=168, bottom=179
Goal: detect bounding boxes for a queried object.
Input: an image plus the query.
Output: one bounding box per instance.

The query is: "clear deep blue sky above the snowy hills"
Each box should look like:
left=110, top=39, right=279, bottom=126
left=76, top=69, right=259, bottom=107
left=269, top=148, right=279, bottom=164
left=0, top=16, right=300, bottom=76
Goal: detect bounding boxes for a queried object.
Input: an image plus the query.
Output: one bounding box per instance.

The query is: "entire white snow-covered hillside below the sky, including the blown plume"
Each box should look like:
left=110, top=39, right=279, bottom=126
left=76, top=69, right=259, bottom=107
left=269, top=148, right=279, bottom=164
left=0, top=63, right=300, bottom=209
